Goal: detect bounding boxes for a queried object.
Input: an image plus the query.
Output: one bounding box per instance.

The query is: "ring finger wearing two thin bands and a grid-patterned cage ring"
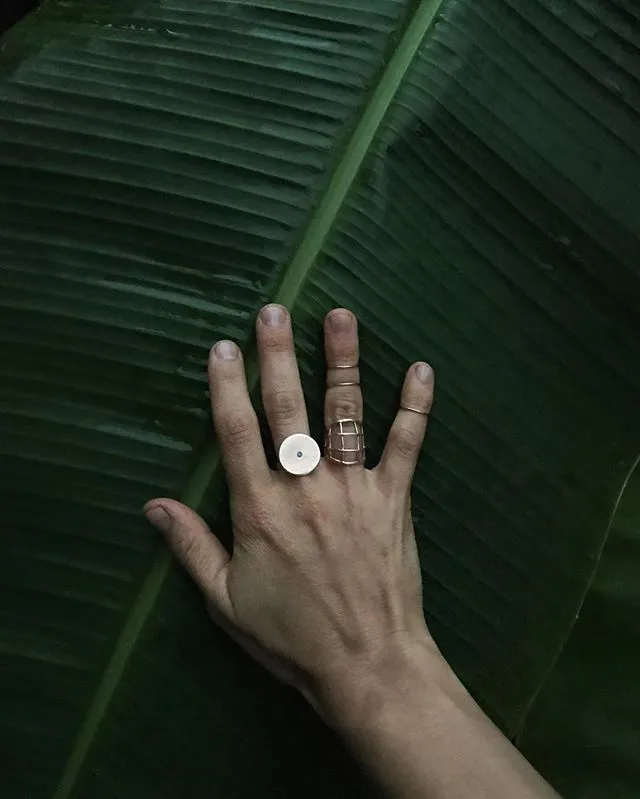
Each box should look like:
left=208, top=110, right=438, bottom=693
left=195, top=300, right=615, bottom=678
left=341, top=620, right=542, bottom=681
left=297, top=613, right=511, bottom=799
left=324, top=308, right=363, bottom=464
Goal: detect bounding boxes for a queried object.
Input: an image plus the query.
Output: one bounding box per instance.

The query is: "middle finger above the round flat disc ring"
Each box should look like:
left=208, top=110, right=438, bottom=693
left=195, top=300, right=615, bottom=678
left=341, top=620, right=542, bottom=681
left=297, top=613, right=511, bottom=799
left=256, top=305, right=309, bottom=452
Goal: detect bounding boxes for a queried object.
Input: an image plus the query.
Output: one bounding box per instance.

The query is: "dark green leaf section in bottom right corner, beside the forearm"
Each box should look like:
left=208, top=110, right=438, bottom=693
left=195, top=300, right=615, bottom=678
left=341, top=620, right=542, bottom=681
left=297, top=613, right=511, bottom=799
left=521, top=468, right=640, bottom=799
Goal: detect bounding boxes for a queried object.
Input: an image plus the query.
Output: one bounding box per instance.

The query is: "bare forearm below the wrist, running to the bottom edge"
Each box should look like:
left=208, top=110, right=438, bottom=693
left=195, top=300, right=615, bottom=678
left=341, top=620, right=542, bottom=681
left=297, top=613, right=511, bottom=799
left=322, top=647, right=557, bottom=799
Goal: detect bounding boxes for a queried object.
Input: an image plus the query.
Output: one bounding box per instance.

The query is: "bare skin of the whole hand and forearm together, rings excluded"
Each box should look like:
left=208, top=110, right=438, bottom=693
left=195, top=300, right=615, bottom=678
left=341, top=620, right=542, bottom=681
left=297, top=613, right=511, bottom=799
left=145, top=305, right=557, bottom=799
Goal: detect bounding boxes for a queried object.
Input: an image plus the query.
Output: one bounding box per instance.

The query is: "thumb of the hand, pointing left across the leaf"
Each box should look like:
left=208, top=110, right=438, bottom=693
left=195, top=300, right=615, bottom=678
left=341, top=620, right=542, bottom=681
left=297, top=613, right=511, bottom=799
left=144, top=497, right=231, bottom=618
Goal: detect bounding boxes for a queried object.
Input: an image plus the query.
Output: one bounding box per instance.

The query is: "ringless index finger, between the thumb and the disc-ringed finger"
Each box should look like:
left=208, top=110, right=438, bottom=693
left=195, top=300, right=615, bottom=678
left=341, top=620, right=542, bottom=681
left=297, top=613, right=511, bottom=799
left=209, top=341, right=270, bottom=490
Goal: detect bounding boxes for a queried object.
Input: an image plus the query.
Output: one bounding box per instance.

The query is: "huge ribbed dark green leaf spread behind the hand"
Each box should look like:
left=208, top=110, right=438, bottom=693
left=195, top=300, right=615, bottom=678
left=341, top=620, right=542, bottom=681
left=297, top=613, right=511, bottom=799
left=0, top=0, right=640, bottom=799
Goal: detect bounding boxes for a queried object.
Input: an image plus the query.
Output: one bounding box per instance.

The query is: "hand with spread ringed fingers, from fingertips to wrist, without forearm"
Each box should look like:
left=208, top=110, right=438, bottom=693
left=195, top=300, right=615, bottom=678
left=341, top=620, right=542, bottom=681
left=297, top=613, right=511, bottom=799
left=145, top=305, right=435, bottom=718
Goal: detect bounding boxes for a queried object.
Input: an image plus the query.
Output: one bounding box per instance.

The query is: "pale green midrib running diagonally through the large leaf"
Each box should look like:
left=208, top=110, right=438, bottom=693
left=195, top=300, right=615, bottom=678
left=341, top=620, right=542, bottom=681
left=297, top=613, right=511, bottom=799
left=53, top=0, right=444, bottom=799
